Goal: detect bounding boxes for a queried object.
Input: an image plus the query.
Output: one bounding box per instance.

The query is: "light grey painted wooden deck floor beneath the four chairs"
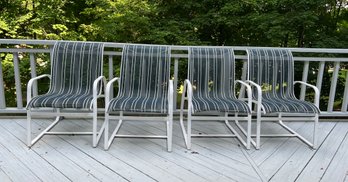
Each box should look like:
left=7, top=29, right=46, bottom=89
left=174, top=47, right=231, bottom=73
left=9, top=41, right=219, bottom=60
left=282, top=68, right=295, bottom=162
left=0, top=119, right=348, bottom=182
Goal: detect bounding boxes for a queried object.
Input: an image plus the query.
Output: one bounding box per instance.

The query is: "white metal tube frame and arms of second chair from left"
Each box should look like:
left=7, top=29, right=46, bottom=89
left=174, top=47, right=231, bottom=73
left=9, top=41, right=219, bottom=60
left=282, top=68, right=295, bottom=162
left=104, top=77, right=174, bottom=152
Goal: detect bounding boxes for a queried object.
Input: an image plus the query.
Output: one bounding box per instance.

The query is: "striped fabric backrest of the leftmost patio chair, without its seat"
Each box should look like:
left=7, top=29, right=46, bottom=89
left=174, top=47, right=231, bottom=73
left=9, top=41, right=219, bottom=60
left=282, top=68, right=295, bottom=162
left=48, top=41, right=104, bottom=95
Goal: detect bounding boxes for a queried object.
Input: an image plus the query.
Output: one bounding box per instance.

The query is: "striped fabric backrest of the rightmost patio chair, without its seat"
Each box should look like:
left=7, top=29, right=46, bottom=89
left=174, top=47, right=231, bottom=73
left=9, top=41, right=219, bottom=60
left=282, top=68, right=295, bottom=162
left=248, top=49, right=295, bottom=98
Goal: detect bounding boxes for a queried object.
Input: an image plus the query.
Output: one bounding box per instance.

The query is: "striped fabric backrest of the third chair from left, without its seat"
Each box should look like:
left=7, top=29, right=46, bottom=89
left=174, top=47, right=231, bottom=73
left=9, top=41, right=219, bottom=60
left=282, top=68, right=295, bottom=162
left=188, top=47, right=235, bottom=98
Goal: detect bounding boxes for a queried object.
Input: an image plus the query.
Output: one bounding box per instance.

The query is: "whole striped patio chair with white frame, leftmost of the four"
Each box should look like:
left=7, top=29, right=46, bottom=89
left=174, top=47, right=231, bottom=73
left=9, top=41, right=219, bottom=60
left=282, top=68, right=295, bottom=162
left=26, top=41, right=106, bottom=147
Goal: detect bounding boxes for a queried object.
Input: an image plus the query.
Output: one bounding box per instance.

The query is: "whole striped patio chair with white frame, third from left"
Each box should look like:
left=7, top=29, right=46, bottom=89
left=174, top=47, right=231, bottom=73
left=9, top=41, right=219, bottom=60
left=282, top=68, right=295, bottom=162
left=180, top=47, right=252, bottom=149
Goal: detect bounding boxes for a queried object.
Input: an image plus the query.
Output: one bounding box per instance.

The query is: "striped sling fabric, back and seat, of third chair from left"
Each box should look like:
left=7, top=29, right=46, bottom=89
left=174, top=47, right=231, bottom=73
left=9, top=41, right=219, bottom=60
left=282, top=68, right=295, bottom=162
left=188, top=47, right=250, bottom=113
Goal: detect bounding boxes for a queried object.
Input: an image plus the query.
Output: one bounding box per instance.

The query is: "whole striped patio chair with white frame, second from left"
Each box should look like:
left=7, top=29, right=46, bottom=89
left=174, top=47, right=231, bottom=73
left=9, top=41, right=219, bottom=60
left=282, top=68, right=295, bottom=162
left=104, top=45, right=173, bottom=152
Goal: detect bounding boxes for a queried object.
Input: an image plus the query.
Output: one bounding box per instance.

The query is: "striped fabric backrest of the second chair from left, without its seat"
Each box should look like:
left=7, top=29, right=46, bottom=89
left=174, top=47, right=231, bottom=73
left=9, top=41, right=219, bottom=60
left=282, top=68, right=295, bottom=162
left=119, top=45, right=170, bottom=101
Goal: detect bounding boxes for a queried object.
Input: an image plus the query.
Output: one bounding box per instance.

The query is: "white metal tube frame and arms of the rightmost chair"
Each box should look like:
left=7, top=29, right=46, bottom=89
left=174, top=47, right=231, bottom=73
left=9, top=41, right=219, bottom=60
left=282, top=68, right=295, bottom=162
left=237, top=48, right=320, bottom=149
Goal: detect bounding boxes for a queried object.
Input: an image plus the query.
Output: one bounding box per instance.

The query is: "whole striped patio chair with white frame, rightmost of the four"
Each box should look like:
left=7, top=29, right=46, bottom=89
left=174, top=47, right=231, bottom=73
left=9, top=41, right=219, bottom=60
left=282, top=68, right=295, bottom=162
left=247, top=48, right=320, bottom=149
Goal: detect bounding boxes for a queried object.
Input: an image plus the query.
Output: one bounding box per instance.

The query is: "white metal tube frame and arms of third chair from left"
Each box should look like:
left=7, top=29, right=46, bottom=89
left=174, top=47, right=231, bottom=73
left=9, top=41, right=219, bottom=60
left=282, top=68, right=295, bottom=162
left=180, top=79, right=252, bottom=150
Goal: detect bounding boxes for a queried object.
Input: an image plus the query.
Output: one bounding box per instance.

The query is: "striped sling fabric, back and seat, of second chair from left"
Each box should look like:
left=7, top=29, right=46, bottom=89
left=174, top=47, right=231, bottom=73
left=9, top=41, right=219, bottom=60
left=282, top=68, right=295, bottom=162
left=108, top=45, right=170, bottom=113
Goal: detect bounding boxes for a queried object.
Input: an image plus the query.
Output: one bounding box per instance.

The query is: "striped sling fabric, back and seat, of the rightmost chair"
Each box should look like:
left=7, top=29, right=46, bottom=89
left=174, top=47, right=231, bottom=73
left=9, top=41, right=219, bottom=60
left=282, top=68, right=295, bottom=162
left=248, top=49, right=319, bottom=113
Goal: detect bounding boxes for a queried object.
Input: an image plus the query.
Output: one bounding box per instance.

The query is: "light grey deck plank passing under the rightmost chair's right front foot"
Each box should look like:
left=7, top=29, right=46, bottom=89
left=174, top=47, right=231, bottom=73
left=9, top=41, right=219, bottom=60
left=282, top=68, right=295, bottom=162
left=271, top=122, right=336, bottom=182
